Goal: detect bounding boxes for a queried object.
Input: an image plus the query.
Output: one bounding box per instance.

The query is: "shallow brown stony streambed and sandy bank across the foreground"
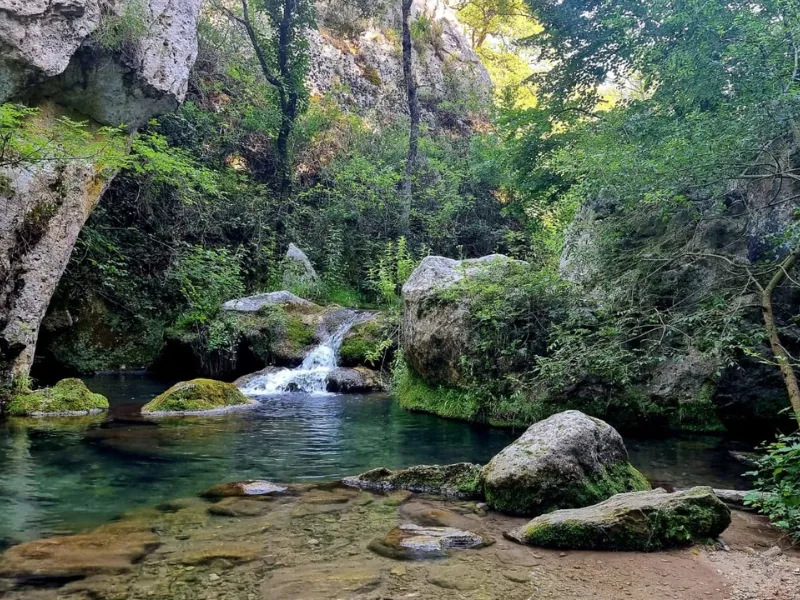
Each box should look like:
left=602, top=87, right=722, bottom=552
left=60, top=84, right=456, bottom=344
left=0, top=484, right=800, bottom=600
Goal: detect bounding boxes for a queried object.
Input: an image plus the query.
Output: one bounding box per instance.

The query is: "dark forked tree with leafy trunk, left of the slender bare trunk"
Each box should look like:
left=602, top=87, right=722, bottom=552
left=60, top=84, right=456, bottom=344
left=223, top=0, right=314, bottom=196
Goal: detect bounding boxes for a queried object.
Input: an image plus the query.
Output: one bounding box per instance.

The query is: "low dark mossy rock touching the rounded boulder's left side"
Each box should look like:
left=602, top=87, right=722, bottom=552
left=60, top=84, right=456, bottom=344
left=342, top=463, right=481, bottom=499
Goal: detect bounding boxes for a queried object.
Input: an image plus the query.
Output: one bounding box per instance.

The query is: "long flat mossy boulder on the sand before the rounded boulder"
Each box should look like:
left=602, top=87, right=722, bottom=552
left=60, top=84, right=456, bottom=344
left=508, top=487, right=731, bottom=552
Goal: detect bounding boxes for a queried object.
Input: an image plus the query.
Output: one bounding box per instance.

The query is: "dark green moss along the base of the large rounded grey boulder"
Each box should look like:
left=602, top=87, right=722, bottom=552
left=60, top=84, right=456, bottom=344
left=485, top=462, right=650, bottom=516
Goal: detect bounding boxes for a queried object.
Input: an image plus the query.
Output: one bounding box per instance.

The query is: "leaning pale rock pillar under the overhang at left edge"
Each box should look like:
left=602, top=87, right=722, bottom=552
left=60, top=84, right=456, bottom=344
left=0, top=162, right=109, bottom=411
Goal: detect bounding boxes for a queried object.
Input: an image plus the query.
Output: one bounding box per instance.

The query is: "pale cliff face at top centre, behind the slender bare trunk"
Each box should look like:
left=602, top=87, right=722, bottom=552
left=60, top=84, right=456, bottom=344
left=309, top=0, right=492, bottom=120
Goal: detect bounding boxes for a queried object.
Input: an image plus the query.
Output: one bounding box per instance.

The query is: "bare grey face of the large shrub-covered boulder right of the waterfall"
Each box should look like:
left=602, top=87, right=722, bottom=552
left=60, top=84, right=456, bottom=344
left=402, top=254, right=512, bottom=386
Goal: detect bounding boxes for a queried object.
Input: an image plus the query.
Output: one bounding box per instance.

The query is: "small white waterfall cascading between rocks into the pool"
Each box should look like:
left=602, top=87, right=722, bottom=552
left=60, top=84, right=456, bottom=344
left=234, top=310, right=369, bottom=396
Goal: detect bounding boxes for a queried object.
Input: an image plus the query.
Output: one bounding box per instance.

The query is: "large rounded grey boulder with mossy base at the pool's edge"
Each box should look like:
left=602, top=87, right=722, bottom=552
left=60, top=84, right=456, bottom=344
left=481, top=410, right=650, bottom=516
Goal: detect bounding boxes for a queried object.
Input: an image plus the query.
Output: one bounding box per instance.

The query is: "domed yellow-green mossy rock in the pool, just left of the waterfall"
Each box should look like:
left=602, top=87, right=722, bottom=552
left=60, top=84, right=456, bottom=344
left=142, top=379, right=258, bottom=415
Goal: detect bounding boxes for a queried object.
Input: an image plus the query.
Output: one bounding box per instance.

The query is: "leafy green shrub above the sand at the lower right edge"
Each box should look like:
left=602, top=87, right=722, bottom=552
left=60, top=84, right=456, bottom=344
left=745, top=433, right=800, bottom=543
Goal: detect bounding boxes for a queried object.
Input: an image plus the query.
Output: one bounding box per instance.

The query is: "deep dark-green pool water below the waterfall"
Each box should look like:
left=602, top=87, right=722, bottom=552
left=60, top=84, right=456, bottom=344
left=0, top=376, right=744, bottom=546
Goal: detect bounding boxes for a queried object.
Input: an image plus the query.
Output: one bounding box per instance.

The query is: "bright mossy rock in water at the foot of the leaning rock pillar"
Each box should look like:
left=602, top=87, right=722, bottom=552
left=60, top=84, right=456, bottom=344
left=8, top=379, right=108, bottom=417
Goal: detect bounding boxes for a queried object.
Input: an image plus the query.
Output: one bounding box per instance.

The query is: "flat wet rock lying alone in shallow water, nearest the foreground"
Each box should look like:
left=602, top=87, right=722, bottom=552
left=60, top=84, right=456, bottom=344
left=369, top=524, right=494, bottom=560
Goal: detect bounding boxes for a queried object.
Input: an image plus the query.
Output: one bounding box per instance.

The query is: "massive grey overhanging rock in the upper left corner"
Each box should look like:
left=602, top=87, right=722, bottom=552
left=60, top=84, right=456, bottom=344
left=0, top=0, right=200, bottom=127
